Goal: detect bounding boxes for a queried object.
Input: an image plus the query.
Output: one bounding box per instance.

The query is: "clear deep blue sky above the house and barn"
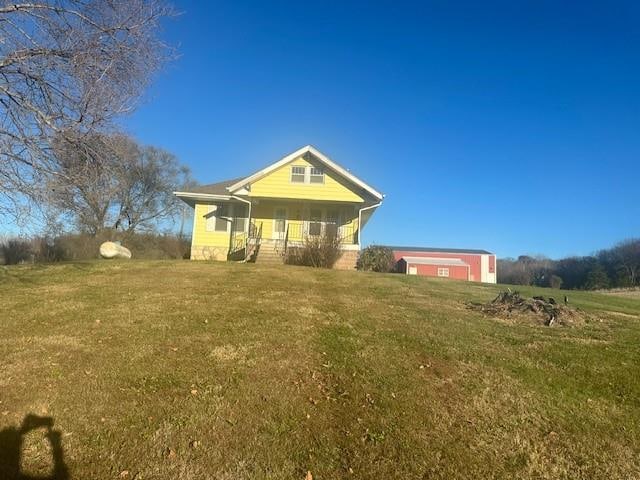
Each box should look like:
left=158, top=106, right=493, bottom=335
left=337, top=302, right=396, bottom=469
left=126, top=0, right=640, bottom=257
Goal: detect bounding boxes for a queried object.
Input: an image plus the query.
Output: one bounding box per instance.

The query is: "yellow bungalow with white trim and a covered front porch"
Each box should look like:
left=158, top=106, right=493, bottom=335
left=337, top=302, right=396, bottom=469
left=174, top=145, right=384, bottom=268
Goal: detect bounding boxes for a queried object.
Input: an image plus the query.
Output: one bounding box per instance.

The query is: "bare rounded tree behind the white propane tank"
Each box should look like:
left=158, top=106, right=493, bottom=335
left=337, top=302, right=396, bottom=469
left=47, top=134, right=191, bottom=235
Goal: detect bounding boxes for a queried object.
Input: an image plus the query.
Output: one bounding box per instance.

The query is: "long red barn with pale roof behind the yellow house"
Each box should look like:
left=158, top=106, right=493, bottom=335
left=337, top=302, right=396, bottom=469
left=389, top=247, right=496, bottom=283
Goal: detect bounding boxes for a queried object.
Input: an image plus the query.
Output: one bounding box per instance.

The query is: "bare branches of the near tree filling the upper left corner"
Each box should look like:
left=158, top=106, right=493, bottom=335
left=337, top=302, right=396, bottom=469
left=0, top=0, right=171, bottom=215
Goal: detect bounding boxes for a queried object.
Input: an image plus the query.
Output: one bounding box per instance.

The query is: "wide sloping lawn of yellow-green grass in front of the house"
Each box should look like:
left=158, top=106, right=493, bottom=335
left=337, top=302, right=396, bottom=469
left=0, top=261, right=640, bottom=480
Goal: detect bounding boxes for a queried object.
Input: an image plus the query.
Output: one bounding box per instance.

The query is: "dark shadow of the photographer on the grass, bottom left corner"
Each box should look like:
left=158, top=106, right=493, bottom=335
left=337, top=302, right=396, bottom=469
left=0, top=414, right=70, bottom=480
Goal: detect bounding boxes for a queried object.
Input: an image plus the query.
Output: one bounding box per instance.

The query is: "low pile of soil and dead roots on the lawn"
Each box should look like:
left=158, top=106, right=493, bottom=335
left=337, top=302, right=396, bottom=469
left=468, top=289, right=585, bottom=326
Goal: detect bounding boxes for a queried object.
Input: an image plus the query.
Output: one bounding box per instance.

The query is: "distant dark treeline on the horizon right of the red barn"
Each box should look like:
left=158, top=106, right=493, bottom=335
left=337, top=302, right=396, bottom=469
left=498, top=238, right=640, bottom=290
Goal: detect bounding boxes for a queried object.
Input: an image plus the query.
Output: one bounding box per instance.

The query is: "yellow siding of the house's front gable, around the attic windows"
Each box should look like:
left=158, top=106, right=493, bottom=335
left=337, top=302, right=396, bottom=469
left=250, top=157, right=364, bottom=203
